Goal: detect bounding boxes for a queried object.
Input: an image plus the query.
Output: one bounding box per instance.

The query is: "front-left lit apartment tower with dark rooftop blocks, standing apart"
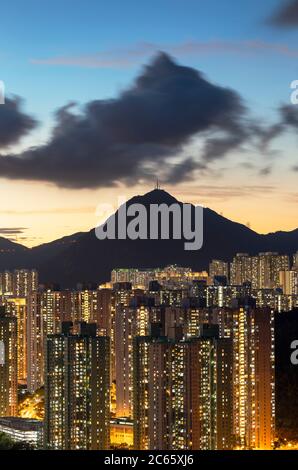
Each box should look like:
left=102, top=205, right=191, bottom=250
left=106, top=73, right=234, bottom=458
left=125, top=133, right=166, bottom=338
left=45, top=323, right=110, bottom=450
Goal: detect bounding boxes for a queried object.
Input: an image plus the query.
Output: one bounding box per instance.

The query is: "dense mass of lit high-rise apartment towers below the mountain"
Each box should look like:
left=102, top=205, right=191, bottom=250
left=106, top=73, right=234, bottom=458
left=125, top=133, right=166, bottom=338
left=0, top=262, right=288, bottom=450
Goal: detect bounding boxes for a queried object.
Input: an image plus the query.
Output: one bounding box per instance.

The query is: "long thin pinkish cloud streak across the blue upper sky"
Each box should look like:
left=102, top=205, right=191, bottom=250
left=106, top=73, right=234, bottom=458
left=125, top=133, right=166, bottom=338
left=30, top=40, right=298, bottom=68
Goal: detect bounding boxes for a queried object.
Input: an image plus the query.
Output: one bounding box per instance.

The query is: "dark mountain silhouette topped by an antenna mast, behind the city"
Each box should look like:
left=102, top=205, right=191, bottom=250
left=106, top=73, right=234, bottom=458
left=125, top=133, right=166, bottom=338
left=0, top=189, right=298, bottom=287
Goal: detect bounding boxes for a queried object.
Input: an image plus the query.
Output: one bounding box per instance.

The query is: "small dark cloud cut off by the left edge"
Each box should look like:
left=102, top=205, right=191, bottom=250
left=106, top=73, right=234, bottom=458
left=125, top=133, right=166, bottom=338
left=0, top=97, right=36, bottom=149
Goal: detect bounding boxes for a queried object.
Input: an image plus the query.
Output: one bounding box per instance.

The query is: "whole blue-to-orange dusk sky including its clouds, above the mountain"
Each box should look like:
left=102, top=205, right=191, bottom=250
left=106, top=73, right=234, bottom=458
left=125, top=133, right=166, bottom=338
left=0, top=0, right=298, bottom=246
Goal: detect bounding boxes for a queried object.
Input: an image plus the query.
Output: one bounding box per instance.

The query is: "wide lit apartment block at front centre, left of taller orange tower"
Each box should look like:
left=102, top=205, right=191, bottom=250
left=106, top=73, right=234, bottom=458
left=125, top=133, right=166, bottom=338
left=133, top=327, right=233, bottom=450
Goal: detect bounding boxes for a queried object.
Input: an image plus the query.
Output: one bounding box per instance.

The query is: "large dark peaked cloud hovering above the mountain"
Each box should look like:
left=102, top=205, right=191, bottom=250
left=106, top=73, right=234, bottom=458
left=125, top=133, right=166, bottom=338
left=0, top=53, right=250, bottom=188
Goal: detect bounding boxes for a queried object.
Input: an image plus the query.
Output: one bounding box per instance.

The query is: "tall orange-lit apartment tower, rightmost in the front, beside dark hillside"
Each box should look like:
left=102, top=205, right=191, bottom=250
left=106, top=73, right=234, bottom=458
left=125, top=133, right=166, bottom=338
left=221, top=302, right=275, bottom=449
